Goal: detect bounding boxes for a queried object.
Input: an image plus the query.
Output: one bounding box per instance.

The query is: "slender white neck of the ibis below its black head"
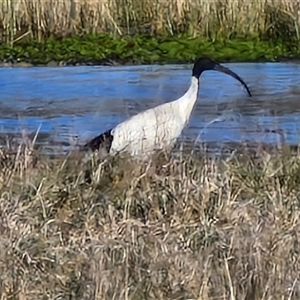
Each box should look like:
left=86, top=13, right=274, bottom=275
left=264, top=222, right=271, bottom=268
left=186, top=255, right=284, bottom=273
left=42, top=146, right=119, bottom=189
left=176, top=76, right=199, bottom=122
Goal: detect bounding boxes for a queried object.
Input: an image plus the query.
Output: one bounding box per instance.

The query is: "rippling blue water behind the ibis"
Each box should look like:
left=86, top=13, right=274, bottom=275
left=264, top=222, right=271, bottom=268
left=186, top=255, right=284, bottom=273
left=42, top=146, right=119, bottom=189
left=0, top=63, right=300, bottom=151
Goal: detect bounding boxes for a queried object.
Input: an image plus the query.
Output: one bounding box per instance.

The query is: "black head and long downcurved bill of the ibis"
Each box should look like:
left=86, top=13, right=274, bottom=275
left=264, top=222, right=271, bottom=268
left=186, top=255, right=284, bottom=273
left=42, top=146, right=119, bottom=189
left=192, top=57, right=251, bottom=97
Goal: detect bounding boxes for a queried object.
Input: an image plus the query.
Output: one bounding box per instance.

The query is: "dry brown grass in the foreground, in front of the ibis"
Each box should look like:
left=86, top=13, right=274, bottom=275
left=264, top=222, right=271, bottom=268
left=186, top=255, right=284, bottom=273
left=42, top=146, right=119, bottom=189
left=0, top=140, right=300, bottom=300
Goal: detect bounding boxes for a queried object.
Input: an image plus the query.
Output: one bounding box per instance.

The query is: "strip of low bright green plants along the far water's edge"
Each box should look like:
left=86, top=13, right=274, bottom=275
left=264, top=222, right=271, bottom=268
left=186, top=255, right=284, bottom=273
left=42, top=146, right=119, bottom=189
left=0, top=34, right=300, bottom=65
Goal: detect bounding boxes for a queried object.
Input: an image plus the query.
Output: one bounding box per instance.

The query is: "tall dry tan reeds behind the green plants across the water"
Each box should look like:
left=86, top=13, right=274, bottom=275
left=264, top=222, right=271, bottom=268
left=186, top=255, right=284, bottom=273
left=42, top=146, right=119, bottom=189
left=0, top=0, right=300, bottom=41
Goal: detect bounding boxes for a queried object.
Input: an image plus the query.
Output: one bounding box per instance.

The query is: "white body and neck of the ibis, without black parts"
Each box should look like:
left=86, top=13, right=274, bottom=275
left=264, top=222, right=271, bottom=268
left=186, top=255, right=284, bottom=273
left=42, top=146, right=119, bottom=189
left=109, top=77, right=199, bottom=156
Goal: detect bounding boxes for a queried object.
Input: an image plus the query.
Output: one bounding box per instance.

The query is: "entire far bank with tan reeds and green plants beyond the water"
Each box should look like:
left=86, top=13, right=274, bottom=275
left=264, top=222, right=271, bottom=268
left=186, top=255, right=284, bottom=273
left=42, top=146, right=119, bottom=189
left=0, top=0, right=300, bottom=65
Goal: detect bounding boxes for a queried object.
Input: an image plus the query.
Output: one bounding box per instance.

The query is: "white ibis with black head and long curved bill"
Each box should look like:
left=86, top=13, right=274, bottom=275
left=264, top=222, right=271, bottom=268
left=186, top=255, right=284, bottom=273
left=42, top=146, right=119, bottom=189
left=83, top=57, right=252, bottom=156
